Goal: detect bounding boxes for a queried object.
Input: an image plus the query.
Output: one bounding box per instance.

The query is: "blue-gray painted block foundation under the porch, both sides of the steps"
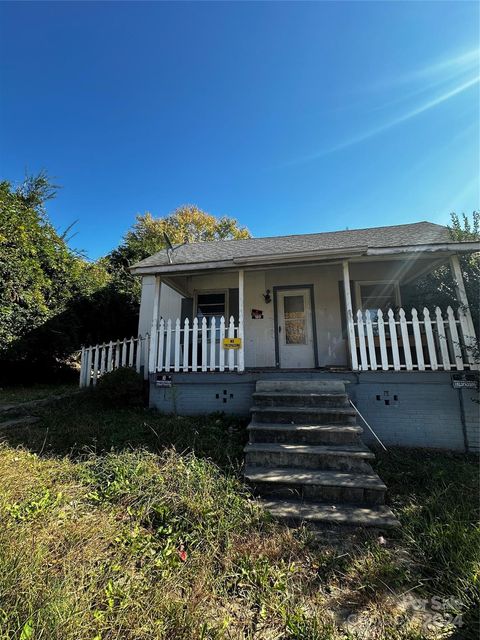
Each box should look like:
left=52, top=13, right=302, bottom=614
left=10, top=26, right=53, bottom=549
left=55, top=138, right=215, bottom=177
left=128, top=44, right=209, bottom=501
left=150, top=371, right=480, bottom=452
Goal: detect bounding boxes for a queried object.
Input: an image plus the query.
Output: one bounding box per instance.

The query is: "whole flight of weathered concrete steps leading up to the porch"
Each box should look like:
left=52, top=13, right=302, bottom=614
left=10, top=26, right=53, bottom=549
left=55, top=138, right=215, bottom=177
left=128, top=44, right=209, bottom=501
left=245, top=380, right=398, bottom=527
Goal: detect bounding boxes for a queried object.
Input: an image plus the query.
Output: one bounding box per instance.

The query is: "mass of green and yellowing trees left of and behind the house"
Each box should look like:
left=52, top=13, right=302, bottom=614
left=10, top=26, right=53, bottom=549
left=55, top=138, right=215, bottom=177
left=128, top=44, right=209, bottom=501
left=0, top=180, right=249, bottom=381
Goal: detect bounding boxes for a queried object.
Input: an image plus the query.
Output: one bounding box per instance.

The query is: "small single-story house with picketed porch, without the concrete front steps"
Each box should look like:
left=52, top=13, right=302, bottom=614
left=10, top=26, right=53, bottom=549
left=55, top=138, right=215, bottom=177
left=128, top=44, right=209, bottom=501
left=82, top=222, right=480, bottom=451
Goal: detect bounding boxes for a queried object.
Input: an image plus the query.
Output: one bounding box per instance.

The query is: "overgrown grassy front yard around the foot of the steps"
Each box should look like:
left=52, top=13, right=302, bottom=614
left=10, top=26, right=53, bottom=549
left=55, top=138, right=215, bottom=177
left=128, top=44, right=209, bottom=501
left=0, top=393, right=480, bottom=640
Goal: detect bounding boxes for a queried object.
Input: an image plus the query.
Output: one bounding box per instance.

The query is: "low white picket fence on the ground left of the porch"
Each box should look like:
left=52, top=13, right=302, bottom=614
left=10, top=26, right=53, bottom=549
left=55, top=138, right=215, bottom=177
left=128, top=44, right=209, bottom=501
left=80, top=334, right=150, bottom=388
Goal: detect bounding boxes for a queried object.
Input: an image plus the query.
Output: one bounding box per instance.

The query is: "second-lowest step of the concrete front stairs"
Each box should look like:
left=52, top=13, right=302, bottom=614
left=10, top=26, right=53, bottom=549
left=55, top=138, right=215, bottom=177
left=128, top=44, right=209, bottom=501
left=244, top=467, right=387, bottom=491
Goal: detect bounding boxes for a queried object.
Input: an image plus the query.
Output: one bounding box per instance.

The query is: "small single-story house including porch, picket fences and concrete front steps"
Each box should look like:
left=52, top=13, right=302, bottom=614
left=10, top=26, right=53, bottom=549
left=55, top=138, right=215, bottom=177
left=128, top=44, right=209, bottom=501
left=81, top=222, right=480, bottom=526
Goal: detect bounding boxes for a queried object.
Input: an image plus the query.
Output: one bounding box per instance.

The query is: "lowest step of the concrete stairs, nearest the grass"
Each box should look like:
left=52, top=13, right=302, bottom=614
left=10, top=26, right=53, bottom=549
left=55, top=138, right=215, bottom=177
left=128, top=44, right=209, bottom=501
left=259, top=500, right=400, bottom=527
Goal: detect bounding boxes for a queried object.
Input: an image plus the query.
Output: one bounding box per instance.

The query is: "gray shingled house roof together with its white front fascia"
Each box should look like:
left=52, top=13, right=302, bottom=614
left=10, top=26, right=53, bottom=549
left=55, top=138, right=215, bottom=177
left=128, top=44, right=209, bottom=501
left=131, top=221, right=480, bottom=274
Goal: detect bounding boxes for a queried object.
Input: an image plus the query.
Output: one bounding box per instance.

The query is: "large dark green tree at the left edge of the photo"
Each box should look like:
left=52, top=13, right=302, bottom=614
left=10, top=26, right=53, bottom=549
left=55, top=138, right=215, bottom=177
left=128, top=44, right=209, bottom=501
left=0, top=172, right=111, bottom=377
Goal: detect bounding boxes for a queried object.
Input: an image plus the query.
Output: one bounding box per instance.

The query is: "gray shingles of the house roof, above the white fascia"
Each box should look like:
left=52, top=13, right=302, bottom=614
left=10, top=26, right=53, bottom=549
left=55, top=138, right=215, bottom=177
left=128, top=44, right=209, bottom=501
left=132, top=222, right=478, bottom=273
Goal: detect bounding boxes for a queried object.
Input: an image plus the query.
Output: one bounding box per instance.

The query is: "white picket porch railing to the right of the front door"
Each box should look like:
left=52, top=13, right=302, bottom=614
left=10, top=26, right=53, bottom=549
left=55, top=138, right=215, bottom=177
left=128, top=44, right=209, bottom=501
left=349, top=307, right=479, bottom=371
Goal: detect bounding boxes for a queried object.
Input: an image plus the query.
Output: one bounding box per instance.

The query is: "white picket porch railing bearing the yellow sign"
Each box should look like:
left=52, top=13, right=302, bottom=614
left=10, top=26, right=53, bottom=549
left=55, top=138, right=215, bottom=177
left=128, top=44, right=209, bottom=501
left=150, top=316, right=245, bottom=372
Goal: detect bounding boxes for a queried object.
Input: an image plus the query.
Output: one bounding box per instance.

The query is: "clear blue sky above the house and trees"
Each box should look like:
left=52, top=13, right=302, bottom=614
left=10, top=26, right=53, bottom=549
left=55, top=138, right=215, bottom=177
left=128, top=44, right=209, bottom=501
left=0, top=2, right=480, bottom=258
